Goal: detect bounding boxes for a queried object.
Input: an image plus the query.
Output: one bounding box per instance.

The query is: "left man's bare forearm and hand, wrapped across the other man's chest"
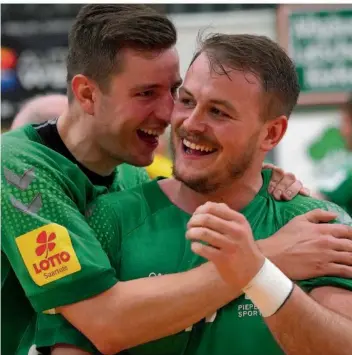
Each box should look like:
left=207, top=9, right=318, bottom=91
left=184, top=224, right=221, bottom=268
left=46, top=210, right=352, bottom=353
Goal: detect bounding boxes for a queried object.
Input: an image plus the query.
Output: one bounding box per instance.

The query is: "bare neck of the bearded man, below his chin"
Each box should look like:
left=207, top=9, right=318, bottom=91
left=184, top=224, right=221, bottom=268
left=159, top=167, right=263, bottom=214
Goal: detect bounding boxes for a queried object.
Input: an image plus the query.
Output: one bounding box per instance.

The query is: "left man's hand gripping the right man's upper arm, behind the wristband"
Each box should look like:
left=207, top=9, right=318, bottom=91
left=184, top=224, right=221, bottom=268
left=257, top=209, right=352, bottom=280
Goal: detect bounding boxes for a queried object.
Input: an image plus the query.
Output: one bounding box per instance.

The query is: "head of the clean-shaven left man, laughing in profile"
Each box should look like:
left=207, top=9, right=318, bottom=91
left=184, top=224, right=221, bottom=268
left=67, top=4, right=180, bottom=168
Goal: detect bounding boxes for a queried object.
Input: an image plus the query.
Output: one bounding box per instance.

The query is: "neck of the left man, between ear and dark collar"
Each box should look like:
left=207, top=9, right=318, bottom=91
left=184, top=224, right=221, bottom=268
left=57, top=111, right=118, bottom=176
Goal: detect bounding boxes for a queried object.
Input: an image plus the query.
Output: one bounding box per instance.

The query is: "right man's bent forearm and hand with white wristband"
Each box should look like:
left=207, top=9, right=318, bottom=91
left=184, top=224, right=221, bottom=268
left=187, top=203, right=352, bottom=355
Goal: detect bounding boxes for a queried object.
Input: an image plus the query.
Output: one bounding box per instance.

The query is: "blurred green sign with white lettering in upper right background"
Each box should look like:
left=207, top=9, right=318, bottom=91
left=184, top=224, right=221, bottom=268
left=277, top=4, right=352, bottom=105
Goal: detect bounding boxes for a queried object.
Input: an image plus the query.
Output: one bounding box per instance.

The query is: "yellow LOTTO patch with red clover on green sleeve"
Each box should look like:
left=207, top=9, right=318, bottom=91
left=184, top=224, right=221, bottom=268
left=16, top=223, right=81, bottom=286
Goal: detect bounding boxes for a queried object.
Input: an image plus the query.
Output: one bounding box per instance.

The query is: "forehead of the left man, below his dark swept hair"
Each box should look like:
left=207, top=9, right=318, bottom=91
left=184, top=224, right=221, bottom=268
left=117, top=48, right=180, bottom=86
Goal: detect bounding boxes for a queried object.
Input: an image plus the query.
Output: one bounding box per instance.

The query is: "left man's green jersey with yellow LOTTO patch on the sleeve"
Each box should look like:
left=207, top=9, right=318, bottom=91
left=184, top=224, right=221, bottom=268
left=1, top=126, right=148, bottom=355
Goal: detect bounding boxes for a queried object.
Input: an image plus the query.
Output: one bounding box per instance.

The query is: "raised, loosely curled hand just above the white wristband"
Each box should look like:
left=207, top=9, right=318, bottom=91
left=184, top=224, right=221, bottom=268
left=186, top=202, right=264, bottom=289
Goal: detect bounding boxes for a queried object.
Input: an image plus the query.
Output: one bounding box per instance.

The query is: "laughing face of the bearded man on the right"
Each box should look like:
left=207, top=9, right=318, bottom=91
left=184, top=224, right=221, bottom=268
left=172, top=53, right=283, bottom=193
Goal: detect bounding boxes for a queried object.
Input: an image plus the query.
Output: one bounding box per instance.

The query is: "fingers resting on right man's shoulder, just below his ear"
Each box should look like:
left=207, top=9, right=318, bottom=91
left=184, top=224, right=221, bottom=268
left=263, top=164, right=310, bottom=201
